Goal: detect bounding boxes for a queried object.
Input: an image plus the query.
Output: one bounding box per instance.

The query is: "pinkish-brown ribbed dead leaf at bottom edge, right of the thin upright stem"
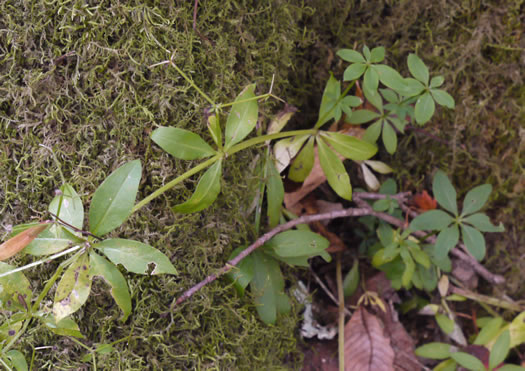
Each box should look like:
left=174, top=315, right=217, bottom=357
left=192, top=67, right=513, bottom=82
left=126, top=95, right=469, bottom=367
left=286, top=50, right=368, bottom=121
left=344, top=307, right=394, bottom=371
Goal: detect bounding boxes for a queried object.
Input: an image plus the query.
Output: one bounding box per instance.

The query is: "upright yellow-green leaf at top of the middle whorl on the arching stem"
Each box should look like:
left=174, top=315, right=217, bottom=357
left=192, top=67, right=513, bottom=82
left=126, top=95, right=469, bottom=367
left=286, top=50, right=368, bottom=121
left=225, top=84, right=259, bottom=149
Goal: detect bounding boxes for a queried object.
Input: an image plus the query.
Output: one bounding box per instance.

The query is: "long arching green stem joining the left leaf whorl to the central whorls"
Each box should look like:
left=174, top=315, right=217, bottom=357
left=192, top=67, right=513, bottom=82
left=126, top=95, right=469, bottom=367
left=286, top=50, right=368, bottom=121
left=129, top=129, right=317, bottom=212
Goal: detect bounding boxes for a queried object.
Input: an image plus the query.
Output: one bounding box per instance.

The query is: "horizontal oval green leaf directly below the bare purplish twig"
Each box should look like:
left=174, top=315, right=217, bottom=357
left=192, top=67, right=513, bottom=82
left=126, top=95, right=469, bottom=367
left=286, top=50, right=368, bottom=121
left=265, top=230, right=330, bottom=258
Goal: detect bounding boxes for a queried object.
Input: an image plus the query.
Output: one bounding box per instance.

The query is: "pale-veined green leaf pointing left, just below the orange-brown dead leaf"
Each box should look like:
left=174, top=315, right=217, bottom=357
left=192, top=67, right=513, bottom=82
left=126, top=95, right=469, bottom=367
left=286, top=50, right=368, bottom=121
left=24, top=224, right=85, bottom=256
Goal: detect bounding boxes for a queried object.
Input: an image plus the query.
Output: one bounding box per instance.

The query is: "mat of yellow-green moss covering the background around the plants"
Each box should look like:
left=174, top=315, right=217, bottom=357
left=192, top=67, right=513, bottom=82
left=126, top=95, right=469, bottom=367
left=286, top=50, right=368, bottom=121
left=0, top=0, right=525, bottom=370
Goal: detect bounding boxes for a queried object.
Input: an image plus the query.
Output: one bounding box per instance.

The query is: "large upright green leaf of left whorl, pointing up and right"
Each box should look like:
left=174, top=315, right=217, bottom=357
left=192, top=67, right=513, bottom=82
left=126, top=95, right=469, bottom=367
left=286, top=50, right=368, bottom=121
left=89, top=160, right=142, bottom=236
